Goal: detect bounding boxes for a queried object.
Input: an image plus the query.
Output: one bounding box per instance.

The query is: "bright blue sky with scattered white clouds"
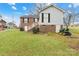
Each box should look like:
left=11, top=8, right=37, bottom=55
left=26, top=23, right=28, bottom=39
left=0, top=3, right=79, bottom=25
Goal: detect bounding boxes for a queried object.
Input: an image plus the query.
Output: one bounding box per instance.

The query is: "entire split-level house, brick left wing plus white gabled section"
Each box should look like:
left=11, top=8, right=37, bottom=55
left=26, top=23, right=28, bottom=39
left=20, top=5, right=65, bottom=33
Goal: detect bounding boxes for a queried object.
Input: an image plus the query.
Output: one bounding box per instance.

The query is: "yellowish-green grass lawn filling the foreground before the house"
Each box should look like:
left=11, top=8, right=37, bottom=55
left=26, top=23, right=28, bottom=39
left=0, top=29, right=79, bottom=56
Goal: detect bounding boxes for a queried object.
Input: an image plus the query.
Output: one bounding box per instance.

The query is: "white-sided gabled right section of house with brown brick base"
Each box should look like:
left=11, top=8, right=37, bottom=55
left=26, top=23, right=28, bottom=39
left=39, top=5, right=65, bottom=32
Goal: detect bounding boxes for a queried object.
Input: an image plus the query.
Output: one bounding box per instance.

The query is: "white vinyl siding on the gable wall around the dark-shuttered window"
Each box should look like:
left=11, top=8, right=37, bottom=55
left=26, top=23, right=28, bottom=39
left=39, top=7, right=63, bottom=25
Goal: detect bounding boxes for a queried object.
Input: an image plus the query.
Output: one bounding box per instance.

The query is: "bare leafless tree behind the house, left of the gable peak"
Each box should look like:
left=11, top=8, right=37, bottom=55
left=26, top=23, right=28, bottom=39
left=30, top=3, right=56, bottom=15
